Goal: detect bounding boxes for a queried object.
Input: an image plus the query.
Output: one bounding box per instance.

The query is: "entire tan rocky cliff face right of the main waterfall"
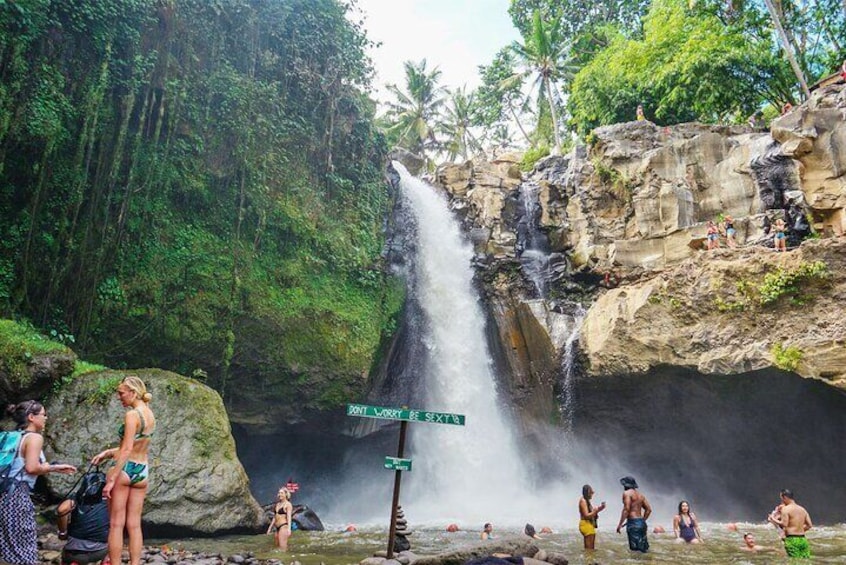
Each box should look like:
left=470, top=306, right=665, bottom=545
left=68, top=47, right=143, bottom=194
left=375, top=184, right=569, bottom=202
left=436, top=86, right=846, bottom=390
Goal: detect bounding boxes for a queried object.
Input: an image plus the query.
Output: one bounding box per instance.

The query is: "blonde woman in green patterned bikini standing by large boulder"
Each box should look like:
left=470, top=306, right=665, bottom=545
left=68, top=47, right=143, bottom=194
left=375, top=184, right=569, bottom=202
left=91, top=375, right=156, bottom=565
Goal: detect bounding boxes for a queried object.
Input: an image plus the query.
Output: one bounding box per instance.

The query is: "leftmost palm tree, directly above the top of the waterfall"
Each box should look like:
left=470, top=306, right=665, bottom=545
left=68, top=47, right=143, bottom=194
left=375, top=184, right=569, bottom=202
left=386, top=59, right=445, bottom=157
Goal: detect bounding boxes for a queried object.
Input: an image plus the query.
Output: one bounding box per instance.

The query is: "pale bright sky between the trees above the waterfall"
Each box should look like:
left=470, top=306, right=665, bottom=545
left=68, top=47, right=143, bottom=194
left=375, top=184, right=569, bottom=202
left=358, top=0, right=519, bottom=101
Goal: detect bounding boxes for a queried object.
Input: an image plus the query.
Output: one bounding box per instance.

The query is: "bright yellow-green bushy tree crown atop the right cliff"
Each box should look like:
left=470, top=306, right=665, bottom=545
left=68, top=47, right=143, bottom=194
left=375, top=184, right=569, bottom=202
left=569, top=0, right=779, bottom=135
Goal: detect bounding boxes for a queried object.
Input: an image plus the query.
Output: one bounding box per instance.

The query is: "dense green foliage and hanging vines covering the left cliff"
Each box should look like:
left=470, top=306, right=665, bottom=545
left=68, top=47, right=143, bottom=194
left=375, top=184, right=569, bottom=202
left=0, top=0, right=402, bottom=414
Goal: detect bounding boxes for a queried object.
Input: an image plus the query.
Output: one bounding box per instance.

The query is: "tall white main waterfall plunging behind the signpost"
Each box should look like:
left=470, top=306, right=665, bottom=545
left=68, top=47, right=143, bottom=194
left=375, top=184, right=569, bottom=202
left=394, top=163, right=527, bottom=524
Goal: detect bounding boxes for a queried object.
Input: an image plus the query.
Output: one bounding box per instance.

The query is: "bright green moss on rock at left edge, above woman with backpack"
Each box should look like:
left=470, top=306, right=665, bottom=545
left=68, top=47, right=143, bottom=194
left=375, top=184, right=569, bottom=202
left=0, top=320, right=71, bottom=385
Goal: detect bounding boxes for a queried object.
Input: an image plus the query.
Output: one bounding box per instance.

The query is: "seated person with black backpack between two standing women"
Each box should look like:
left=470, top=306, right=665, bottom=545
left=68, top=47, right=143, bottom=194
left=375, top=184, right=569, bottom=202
left=56, top=471, right=109, bottom=565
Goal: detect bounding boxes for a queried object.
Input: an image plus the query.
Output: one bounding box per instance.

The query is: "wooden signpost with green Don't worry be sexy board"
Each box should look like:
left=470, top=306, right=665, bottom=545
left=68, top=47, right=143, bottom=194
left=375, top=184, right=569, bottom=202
left=347, top=404, right=465, bottom=559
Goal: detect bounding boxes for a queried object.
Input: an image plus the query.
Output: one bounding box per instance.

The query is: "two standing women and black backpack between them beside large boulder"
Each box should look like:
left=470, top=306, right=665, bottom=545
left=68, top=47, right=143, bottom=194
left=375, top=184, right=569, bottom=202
left=0, top=375, right=156, bottom=565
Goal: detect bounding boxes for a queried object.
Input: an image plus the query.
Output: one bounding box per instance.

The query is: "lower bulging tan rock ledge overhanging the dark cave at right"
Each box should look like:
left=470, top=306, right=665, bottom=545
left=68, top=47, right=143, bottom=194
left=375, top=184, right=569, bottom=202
left=581, top=238, right=846, bottom=389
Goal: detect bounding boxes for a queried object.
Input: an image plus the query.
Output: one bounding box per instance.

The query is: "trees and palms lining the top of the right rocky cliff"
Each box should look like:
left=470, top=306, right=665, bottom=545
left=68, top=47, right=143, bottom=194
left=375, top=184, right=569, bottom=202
left=386, top=0, right=846, bottom=161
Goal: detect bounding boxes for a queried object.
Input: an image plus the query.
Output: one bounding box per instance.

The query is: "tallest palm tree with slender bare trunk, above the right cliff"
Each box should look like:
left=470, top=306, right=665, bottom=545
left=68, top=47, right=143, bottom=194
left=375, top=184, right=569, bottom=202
left=504, top=11, right=573, bottom=153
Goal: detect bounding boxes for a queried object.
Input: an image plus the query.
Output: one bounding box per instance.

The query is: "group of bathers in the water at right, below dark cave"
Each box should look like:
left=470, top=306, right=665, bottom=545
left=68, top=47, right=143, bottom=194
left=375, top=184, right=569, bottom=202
left=579, top=476, right=813, bottom=558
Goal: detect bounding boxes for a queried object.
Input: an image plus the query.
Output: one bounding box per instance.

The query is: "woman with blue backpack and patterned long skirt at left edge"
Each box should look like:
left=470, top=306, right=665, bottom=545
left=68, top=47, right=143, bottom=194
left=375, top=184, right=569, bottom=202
left=0, top=400, right=76, bottom=565
